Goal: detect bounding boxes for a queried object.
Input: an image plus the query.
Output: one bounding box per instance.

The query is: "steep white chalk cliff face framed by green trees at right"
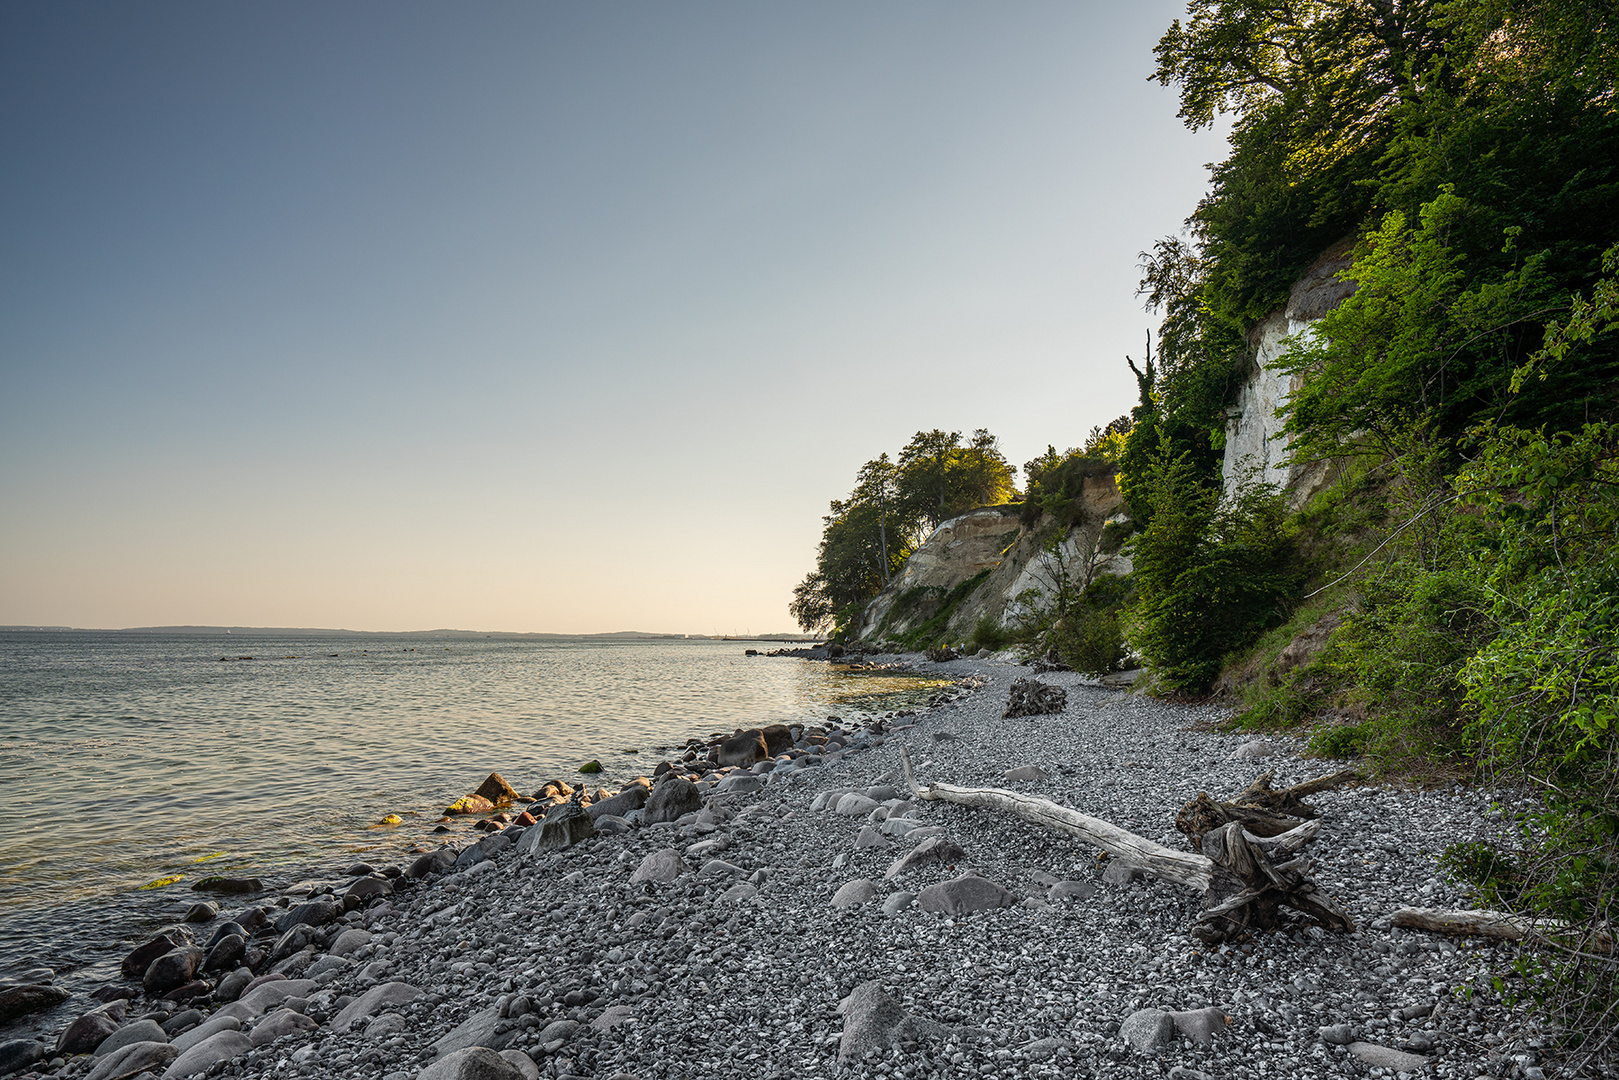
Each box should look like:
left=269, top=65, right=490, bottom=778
left=1222, top=241, right=1355, bottom=508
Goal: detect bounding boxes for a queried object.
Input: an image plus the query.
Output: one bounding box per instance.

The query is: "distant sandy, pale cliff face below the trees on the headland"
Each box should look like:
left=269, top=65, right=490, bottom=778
left=860, top=476, right=1130, bottom=641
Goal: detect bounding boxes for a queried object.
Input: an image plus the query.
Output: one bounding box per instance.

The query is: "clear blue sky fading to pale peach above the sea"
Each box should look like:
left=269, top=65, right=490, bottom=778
left=0, top=0, right=1224, bottom=633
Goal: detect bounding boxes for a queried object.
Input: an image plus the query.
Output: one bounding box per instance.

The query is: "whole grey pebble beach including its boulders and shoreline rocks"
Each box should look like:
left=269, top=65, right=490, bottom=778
left=0, top=657, right=1553, bottom=1080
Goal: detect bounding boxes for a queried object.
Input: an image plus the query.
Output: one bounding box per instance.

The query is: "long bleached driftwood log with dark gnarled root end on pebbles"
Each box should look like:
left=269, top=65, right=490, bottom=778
left=900, top=746, right=1355, bottom=944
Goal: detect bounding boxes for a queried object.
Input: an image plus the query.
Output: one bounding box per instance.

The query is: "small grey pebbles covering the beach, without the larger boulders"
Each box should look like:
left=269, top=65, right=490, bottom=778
left=0, top=661, right=1535, bottom=1080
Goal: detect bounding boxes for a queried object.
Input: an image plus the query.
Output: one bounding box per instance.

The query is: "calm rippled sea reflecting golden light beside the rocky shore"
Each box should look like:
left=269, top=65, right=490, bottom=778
left=0, top=631, right=937, bottom=980
